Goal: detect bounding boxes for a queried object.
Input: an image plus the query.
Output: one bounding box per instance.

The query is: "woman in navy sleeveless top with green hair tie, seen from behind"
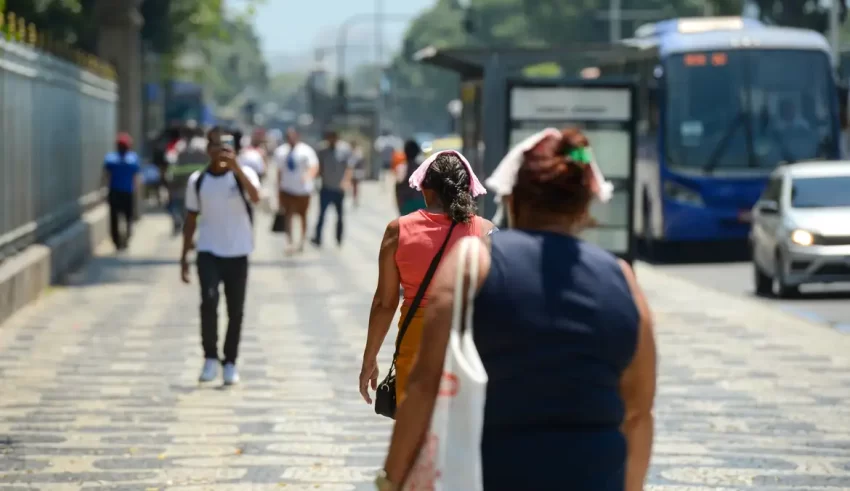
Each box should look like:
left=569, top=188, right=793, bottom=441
left=379, top=129, right=656, bottom=491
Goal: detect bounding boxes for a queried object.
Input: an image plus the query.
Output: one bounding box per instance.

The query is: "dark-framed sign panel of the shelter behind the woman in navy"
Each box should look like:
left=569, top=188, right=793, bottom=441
left=506, top=81, right=635, bottom=259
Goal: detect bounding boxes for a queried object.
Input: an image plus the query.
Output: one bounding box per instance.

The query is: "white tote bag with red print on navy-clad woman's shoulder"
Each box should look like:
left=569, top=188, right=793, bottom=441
left=402, top=239, right=487, bottom=491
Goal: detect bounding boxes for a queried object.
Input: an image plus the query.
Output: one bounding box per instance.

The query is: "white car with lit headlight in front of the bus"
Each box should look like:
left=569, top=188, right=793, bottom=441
left=750, top=160, right=850, bottom=297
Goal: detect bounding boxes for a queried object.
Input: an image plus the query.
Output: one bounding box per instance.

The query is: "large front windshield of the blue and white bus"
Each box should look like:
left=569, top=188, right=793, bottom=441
left=665, top=50, right=838, bottom=172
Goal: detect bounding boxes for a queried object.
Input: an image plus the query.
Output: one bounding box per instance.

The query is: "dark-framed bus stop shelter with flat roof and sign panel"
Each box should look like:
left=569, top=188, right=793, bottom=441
left=414, top=44, right=639, bottom=260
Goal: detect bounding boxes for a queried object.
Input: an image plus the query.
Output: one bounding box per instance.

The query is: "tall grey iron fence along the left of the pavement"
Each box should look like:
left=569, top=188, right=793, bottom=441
left=0, top=18, right=118, bottom=261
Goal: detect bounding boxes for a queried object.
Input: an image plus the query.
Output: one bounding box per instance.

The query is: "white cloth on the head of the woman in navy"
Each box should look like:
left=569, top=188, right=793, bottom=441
left=484, top=128, right=614, bottom=203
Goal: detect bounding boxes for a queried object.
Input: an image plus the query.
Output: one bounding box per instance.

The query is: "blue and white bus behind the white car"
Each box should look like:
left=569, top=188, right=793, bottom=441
left=594, top=17, right=840, bottom=250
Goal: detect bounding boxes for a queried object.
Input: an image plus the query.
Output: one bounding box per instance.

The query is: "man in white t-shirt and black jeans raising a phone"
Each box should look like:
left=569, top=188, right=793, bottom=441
left=180, top=128, right=260, bottom=385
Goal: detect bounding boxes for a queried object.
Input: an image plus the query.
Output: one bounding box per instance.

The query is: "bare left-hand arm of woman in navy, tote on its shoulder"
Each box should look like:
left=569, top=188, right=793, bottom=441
left=384, top=238, right=490, bottom=486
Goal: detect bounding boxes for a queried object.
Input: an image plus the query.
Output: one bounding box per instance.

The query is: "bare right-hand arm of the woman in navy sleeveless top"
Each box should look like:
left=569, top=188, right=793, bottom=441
left=620, top=261, right=657, bottom=491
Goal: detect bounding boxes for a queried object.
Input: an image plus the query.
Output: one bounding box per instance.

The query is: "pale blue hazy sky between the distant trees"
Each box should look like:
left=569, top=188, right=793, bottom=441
left=228, top=0, right=436, bottom=72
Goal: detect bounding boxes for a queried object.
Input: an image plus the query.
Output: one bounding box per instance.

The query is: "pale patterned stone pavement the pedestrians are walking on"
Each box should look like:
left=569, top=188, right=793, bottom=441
left=0, top=182, right=850, bottom=491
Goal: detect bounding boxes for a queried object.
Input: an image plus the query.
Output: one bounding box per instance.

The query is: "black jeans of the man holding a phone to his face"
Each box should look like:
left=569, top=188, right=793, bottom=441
left=198, top=252, right=248, bottom=363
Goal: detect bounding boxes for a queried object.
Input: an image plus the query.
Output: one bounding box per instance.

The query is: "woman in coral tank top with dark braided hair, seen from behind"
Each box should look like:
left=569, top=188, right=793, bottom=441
left=360, top=150, right=494, bottom=404
